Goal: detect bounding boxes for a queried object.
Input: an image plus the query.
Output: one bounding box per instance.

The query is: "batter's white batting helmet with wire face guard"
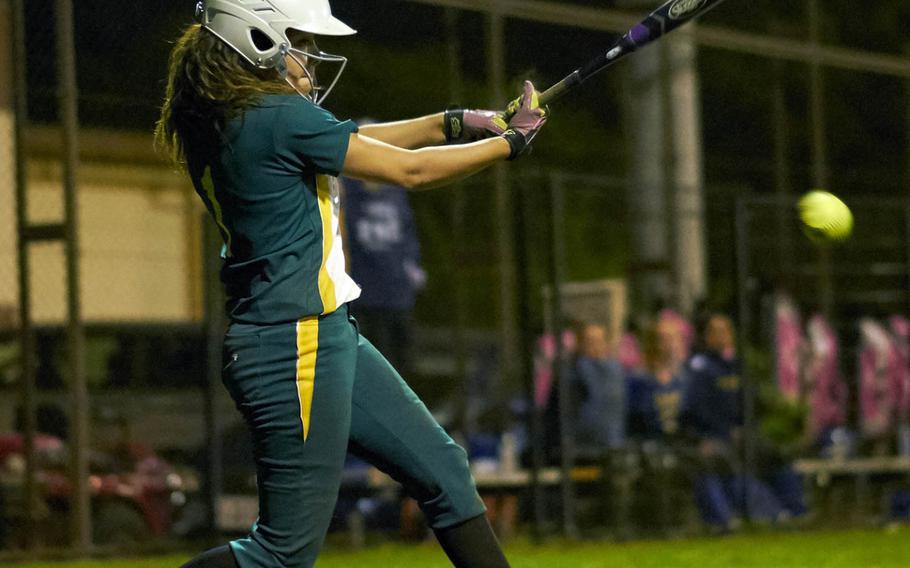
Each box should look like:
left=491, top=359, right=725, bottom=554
left=196, top=0, right=356, bottom=104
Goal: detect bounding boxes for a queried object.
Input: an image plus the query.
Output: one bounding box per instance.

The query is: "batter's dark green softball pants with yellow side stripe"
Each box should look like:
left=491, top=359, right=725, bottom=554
left=223, top=306, right=484, bottom=568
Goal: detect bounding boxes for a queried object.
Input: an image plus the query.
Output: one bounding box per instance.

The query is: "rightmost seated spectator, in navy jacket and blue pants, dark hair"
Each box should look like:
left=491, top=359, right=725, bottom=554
left=684, top=314, right=806, bottom=530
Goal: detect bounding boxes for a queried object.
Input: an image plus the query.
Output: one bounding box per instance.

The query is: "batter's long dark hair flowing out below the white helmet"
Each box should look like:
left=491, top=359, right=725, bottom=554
left=155, top=24, right=294, bottom=167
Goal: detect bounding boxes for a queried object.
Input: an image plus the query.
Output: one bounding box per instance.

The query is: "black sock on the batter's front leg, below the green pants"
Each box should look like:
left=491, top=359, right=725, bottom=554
left=433, top=515, right=509, bottom=568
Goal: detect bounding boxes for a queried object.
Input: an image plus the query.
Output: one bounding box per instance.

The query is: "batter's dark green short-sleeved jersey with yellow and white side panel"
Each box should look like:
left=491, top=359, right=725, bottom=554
left=188, top=95, right=360, bottom=325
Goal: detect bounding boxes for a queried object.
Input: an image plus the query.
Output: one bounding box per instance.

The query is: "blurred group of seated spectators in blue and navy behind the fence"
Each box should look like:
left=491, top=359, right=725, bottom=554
left=535, top=310, right=807, bottom=532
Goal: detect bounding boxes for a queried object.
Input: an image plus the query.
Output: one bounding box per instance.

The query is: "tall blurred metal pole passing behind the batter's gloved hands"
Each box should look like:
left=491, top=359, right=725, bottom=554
left=487, top=6, right=520, bottom=426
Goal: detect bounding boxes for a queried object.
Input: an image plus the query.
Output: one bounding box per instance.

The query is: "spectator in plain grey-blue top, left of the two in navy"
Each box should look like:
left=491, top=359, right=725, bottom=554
left=570, top=323, right=627, bottom=454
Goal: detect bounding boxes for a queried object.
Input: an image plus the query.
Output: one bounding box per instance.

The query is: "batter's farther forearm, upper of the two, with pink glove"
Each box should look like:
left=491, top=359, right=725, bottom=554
left=360, top=109, right=506, bottom=150
